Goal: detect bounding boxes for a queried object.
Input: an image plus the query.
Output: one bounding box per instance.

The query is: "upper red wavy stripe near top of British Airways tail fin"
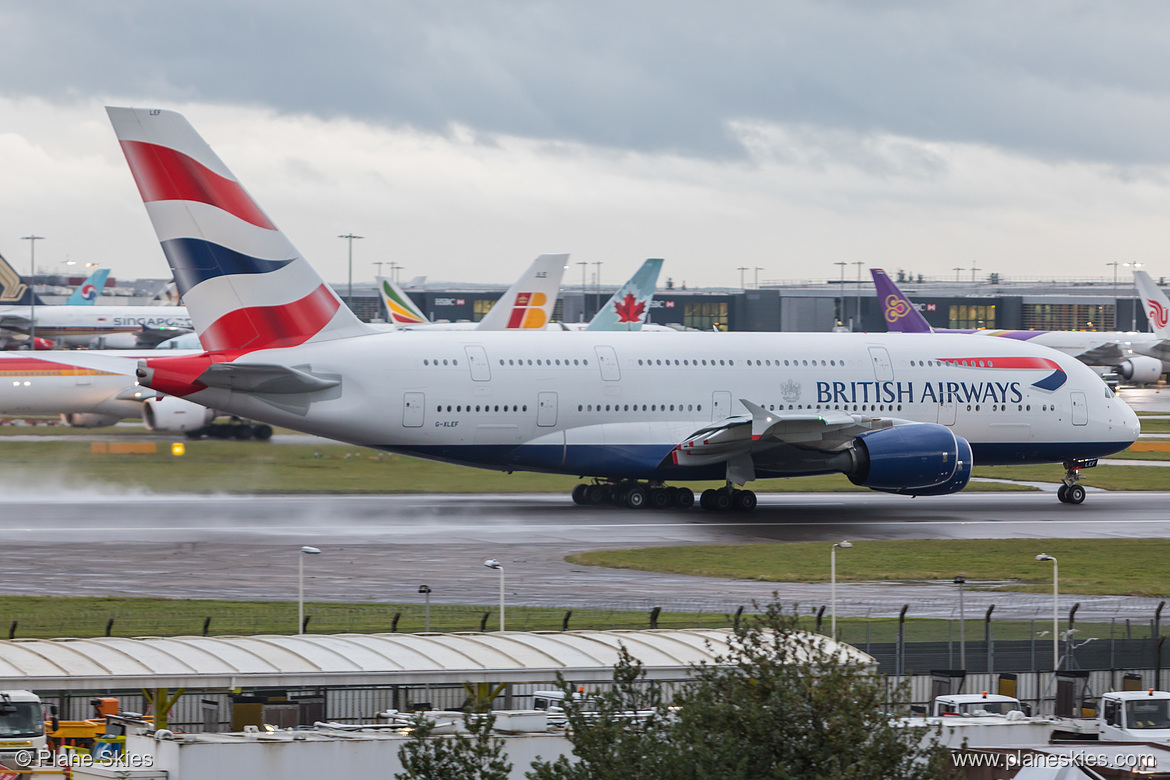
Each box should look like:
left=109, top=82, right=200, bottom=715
left=122, top=140, right=276, bottom=230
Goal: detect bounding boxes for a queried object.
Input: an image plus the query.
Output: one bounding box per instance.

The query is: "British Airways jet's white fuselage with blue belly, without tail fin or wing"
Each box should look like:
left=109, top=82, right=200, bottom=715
left=160, top=331, right=1138, bottom=478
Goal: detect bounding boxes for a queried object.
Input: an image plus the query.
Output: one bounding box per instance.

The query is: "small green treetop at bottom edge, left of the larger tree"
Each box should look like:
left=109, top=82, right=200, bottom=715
left=394, top=711, right=512, bottom=780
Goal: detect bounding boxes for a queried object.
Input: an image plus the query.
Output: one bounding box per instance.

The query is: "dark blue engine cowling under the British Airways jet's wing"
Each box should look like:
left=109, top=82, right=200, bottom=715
left=848, top=422, right=972, bottom=496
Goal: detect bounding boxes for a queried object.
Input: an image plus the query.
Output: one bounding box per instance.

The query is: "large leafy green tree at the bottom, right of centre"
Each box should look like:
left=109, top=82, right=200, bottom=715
left=528, top=603, right=952, bottom=780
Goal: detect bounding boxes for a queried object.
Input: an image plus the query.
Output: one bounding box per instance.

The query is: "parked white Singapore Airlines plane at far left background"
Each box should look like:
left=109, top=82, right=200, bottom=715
left=0, top=251, right=193, bottom=345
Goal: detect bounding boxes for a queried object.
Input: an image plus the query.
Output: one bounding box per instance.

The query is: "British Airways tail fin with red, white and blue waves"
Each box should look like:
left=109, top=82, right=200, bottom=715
left=106, top=108, right=371, bottom=352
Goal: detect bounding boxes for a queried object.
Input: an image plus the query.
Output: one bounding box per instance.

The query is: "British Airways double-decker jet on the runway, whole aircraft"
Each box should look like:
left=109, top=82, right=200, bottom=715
left=108, top=108, right=1138, bottom=510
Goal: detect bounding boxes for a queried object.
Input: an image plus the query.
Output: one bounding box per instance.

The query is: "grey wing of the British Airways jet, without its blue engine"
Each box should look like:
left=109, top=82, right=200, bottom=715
left=670, top=399, right=894, bottom=484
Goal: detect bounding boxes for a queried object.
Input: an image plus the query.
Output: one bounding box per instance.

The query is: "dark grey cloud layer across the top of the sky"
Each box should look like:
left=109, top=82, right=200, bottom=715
left=0, top=0, right=1170, bottom=166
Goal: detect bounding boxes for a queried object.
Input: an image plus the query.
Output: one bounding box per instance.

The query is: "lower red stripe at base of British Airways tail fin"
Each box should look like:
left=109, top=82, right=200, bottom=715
left=199, top=284, right=342, bottom=352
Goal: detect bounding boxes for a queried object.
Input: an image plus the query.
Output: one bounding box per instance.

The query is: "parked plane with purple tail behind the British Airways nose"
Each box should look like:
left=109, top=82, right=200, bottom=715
left=869, top=268, right=1164, bottom=385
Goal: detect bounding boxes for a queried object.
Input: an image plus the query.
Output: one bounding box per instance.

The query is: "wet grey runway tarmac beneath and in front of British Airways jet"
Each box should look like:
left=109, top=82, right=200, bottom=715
left=0, top=490, right=1170, bottom=619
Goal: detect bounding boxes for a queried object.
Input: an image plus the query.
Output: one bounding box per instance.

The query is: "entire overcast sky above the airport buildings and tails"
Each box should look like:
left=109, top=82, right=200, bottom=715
left=0, top=0, right=1170, bottom=287
